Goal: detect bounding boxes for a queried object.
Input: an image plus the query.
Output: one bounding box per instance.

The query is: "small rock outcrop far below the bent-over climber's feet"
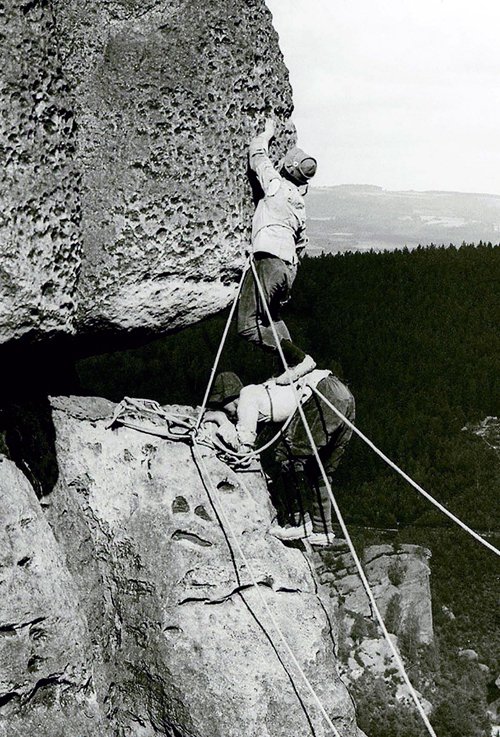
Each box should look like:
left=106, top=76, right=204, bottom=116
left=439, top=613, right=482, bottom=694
left=313, top=540, right=433, bottom=700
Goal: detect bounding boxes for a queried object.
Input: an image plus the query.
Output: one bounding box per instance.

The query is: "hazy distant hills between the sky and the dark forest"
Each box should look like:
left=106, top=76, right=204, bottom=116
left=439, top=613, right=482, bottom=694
left=307, top=184, right=500, bottom=256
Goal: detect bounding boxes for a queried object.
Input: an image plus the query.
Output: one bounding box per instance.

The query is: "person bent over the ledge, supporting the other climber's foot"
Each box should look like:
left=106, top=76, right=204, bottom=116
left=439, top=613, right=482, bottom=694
left=205, top=369, right=355, bottom=546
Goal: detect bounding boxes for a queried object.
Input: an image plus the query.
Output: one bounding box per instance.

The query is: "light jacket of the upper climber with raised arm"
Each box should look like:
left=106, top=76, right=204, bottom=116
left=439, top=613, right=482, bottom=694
left=249, top=135, right=307, bottom=264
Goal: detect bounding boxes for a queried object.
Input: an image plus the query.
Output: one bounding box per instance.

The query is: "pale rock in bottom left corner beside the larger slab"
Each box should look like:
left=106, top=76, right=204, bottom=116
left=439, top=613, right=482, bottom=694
left=0, top=458, right=106, bottom=737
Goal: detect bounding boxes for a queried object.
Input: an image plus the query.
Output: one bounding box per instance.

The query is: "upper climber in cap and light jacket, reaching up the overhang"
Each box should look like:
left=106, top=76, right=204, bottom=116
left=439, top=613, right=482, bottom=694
left=238, top=118, right=317, bottom=383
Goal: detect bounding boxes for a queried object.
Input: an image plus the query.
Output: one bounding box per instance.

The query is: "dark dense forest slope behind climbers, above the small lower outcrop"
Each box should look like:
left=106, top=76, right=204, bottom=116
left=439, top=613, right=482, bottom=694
left=79, top=244, right=500, bottom=531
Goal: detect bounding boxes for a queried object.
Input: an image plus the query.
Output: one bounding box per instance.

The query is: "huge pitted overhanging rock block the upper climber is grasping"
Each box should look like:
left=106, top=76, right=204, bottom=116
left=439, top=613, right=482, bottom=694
left=0, top=0, right=294, bottom=343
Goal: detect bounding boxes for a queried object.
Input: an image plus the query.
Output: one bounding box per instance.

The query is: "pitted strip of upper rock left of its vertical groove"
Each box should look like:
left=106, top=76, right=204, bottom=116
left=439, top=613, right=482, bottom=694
left=0, top=0, right=81, bottom=343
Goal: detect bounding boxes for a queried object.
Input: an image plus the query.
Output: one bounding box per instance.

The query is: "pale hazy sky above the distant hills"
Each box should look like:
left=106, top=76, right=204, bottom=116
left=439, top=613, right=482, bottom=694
left=266, top=0, right=500, bottom=194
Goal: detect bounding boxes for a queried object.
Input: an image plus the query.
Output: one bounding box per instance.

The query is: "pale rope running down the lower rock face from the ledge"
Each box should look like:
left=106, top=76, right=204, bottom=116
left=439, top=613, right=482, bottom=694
left=189, top=435, right=341, bottom=737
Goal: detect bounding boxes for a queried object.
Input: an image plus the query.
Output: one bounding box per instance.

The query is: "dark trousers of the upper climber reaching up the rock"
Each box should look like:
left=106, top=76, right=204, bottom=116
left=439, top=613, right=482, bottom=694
left=238, top=254, right=297, bottom=350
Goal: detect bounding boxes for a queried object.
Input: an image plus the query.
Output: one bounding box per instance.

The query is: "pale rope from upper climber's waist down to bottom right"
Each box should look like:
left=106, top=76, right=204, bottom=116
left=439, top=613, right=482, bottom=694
left=251, top=261, right=437, bottom=737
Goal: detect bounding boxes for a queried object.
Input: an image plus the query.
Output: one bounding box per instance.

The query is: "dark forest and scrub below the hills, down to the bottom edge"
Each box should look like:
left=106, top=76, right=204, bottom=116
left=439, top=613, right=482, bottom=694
left=78, top=244, right=500, bottom=737
